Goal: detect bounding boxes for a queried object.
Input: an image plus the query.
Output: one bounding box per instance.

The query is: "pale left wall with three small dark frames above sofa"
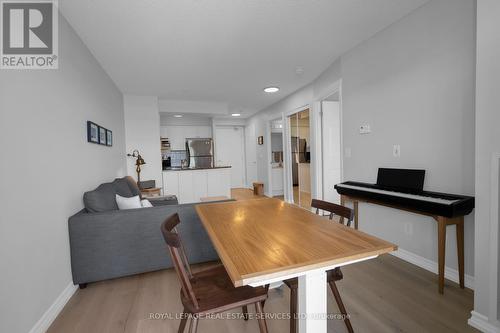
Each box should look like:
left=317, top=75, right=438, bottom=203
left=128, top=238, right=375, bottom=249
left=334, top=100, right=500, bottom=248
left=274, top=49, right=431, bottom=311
left=0, top=16, right=125, bottom=333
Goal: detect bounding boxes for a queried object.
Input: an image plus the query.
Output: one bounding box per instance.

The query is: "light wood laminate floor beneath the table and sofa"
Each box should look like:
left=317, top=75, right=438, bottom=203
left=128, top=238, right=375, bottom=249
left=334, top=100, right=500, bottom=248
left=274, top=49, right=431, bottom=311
left=48, top=189, right=477, bottom=333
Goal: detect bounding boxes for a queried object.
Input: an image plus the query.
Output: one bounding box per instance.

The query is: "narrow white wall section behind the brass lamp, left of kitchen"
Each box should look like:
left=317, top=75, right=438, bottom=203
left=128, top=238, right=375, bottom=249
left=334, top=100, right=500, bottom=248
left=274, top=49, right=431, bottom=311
left=123, top=95, right=162, bottom=186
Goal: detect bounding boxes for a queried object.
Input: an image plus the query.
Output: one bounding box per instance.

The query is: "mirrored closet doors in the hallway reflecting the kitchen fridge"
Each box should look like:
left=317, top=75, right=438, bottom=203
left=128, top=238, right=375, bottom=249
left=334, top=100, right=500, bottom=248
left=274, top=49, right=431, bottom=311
left=286, top=108, right=311, bottom=209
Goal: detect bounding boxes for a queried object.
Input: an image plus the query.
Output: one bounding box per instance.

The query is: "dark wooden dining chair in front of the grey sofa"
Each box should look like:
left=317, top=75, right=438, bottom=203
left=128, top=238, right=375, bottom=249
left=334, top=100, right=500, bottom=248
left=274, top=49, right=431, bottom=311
left=161, top=213, right=267, bottom=333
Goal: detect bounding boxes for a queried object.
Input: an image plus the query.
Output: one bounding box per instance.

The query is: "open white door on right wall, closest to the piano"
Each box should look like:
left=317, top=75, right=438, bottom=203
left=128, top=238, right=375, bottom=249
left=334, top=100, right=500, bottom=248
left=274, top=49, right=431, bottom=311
left=321, top=101, right=342, bottom=203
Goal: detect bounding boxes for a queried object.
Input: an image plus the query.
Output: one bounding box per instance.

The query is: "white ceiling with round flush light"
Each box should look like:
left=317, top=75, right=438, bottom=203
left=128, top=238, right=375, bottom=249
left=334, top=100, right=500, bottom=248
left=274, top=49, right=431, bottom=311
left=60, top=0, right=427, bottom=117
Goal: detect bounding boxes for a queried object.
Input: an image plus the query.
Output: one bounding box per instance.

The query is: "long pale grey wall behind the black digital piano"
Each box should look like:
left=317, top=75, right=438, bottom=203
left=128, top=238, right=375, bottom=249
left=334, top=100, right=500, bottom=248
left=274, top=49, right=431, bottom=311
left=247, top=0, right=475, bottom=275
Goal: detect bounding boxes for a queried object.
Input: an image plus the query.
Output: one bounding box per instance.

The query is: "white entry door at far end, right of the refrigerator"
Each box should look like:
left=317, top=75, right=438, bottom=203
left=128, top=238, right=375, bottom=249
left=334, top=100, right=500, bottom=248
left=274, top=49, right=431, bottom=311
left=215, top=126, right=245, bottom=188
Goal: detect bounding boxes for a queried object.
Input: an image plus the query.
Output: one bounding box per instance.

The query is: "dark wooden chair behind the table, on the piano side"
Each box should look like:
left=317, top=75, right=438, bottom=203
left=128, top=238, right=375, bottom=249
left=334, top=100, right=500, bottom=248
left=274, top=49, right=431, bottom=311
left=283, top=199, right=354, bottom=333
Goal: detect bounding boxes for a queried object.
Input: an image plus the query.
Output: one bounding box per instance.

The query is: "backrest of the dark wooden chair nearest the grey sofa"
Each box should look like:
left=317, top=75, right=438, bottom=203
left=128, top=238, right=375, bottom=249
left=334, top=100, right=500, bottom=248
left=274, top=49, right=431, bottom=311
left=161, top=213, right=199, bottom=308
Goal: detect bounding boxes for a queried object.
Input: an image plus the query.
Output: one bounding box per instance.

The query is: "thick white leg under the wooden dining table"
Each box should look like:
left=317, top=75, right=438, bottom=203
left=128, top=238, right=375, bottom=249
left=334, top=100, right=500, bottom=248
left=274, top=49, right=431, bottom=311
left=298, top=270, right=327, bottom=333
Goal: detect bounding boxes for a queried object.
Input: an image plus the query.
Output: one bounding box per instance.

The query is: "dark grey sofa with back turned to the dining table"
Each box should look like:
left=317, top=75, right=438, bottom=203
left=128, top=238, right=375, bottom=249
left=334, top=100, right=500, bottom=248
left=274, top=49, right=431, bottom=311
left=68, top=178, right=227, bottom=288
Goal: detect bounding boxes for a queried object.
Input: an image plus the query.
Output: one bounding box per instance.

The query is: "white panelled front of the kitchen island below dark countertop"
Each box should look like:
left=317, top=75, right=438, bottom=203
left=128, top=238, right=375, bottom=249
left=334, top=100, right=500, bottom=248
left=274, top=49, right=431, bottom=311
left=162, top=166, right=231, bottom=204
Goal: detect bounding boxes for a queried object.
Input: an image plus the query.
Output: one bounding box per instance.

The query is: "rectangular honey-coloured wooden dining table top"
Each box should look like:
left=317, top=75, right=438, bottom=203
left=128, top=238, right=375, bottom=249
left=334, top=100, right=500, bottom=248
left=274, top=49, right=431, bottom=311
left=196, top=198, right=397, bottom=287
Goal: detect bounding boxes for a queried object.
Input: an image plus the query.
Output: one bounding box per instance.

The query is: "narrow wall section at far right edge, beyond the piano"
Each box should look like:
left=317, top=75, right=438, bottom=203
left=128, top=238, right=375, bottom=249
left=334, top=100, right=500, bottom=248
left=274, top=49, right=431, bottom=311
left=473, top=0, right=500, bottom=331
